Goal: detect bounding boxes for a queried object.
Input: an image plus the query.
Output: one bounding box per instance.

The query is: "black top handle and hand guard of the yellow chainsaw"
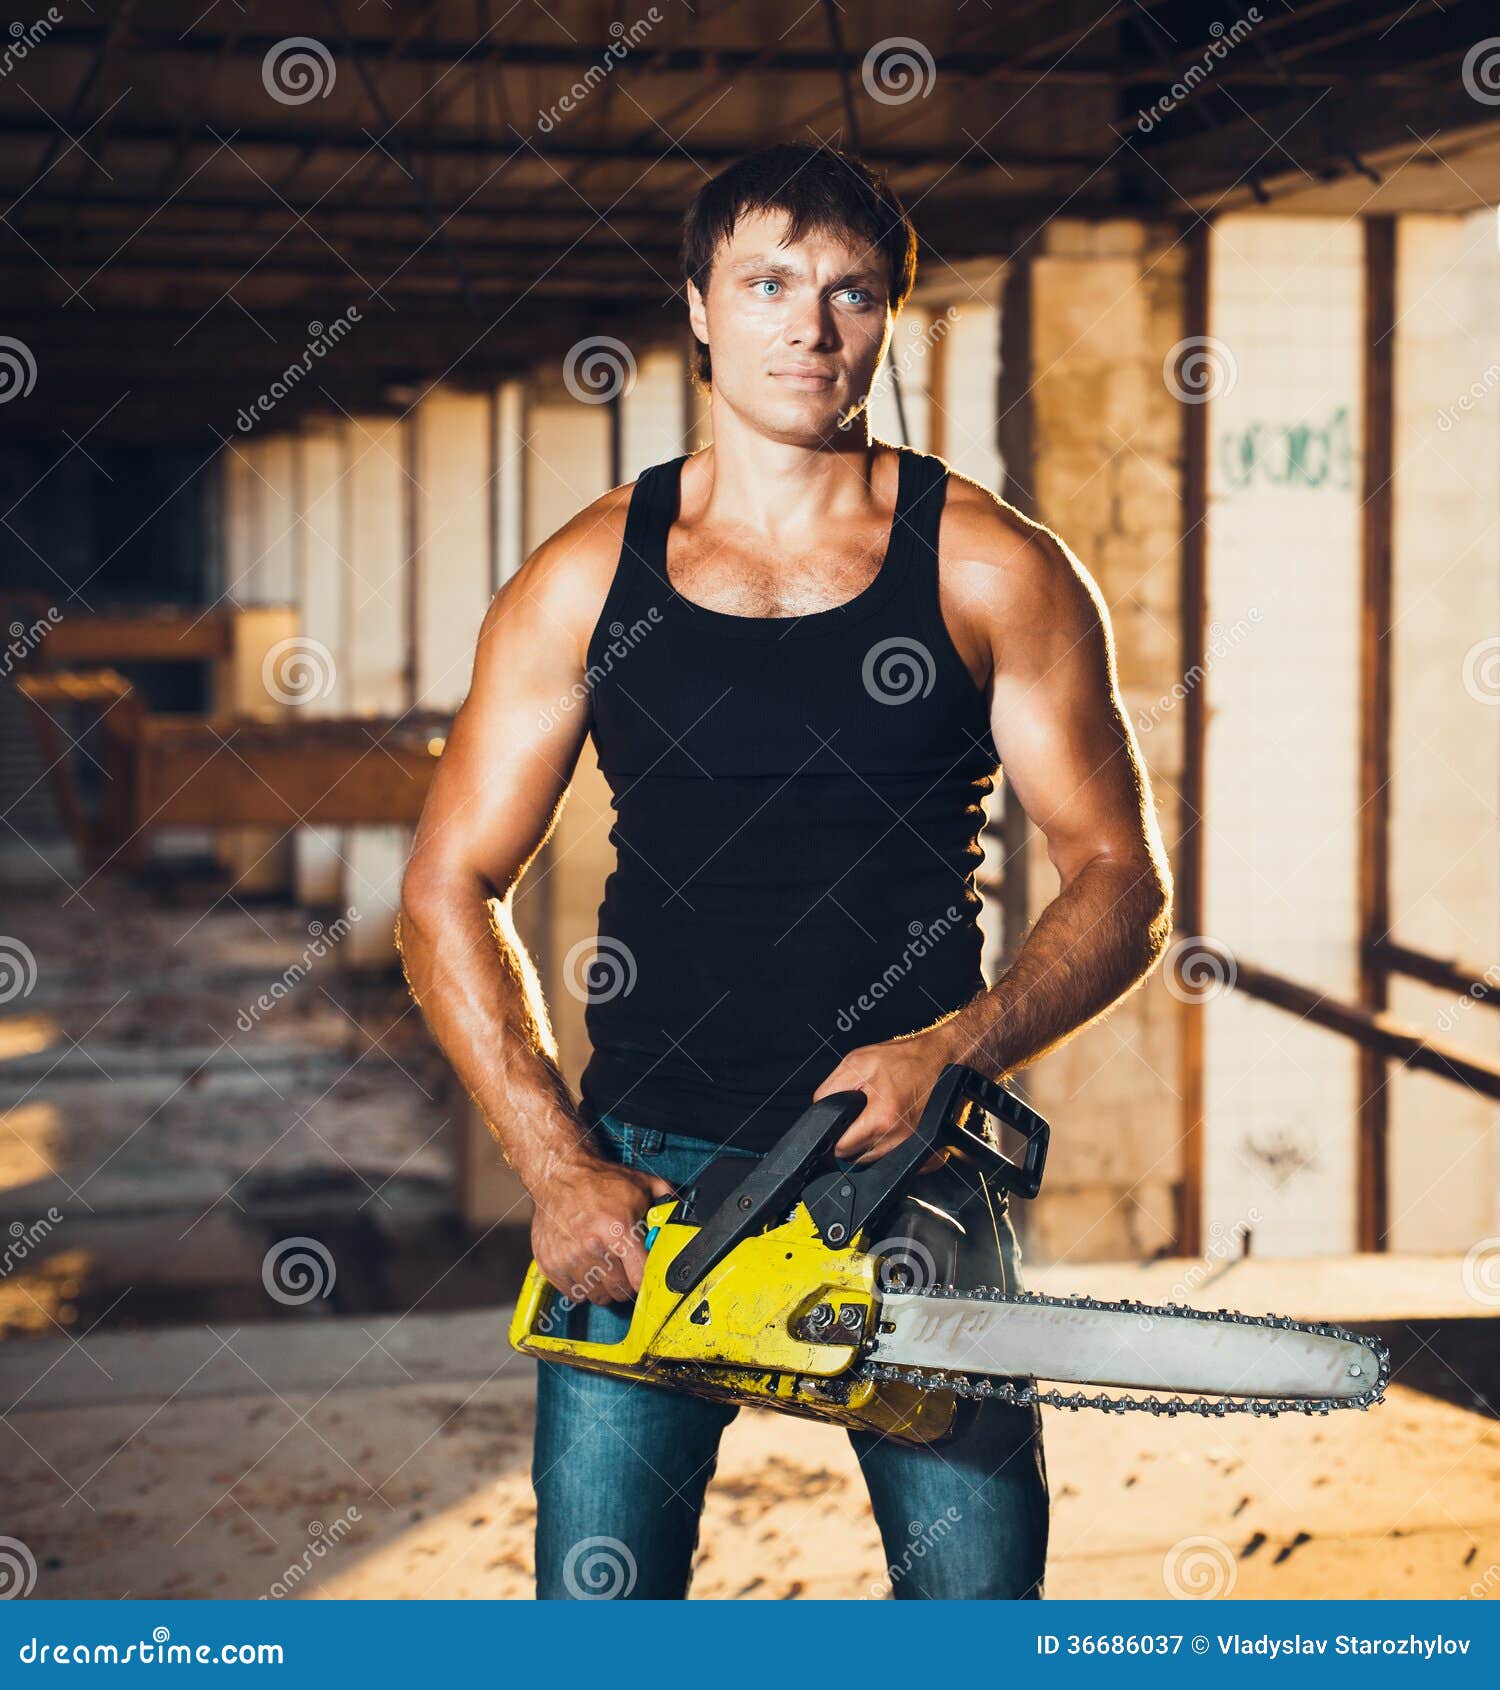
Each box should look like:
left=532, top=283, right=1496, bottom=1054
left=666, top=1063, right=1049, bottom=1291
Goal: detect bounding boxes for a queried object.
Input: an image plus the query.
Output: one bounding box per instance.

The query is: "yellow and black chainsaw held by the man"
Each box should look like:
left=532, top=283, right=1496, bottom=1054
left=510, top=1063, right=1390, bottom=1443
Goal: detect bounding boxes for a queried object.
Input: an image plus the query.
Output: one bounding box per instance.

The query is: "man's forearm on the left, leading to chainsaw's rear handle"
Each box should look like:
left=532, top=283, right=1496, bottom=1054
left=399, top=886, right=608, bottom=1195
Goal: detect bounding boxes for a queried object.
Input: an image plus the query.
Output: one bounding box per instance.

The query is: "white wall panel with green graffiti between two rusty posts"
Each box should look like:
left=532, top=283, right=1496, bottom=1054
left=1202, top=213, right=1365, bottom=1256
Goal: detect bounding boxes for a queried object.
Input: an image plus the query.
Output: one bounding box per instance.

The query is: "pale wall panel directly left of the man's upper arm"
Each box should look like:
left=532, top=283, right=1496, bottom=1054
left=410, top=387, right=495, bottom=710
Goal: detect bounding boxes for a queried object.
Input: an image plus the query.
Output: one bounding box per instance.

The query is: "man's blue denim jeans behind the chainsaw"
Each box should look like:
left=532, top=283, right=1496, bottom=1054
left=532, top=1115, right=1047, bottom=1600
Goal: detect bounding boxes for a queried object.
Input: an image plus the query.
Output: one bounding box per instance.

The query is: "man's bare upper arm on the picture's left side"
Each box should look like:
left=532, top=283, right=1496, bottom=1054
left=412, top=554, right=601, bottom=896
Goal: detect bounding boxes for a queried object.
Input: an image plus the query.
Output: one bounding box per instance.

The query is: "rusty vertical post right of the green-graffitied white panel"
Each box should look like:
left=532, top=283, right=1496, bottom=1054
left=1356, top=216, right=1395, bottom=1251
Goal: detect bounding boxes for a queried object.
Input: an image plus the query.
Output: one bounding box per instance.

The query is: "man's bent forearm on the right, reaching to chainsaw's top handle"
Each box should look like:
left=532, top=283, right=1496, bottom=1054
left=931, top=857, right=1172, bottom=1078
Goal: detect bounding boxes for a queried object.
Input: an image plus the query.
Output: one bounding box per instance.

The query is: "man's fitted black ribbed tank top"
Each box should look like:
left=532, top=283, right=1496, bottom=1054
left=574, top=448, right=998, bottom=1149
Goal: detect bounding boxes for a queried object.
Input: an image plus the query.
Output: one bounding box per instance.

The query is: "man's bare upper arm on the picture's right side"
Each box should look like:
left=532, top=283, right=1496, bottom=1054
left=990, top=537, right=1145, bottom=884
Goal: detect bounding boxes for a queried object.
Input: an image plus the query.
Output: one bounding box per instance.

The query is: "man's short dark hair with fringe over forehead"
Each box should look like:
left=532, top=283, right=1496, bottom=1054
left=682, top=142, right=917, bottom=384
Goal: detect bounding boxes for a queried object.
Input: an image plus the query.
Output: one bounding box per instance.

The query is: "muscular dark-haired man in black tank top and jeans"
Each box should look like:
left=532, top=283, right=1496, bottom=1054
left=402, top=145, right=1171, bottom=1597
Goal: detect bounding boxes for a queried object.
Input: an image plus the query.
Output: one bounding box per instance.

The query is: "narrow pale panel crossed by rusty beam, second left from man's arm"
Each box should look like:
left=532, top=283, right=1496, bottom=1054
left=340, top=416, right=410, bottom=968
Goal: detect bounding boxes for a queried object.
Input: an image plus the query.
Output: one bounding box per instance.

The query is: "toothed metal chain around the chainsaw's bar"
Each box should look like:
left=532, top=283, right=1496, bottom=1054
left=850, top=1284, right=1390, bottom=1420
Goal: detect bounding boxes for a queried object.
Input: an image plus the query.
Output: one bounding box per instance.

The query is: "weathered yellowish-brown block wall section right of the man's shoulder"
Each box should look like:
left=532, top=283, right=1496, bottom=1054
left=1027, top=221, right=1182, bottom=1259
